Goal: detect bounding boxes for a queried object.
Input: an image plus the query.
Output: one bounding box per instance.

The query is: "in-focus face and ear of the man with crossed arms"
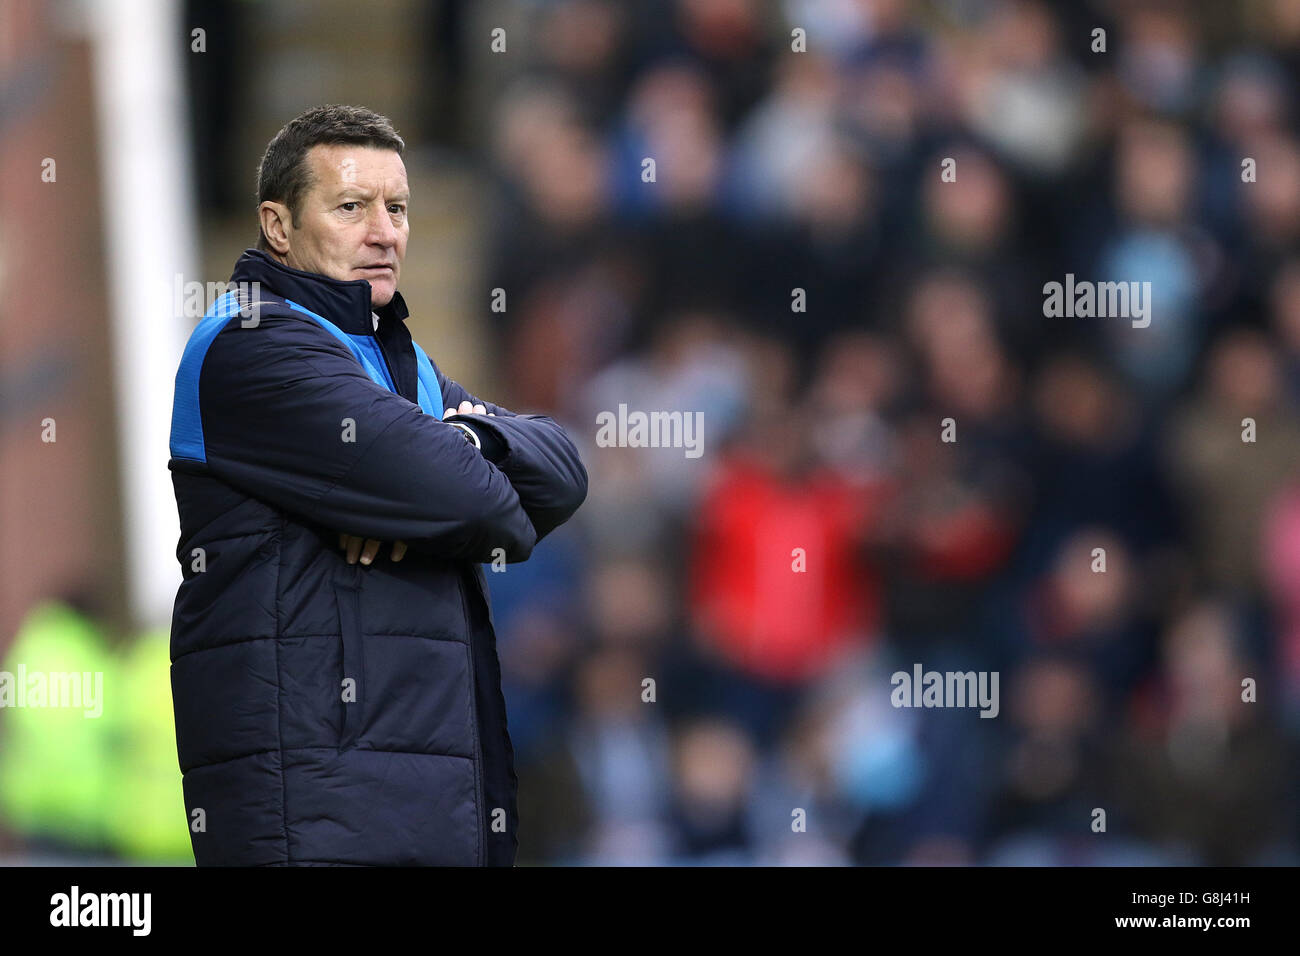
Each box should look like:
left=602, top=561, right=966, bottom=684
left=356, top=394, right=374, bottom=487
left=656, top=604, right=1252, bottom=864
left=259, top=144, right=411, bottom=308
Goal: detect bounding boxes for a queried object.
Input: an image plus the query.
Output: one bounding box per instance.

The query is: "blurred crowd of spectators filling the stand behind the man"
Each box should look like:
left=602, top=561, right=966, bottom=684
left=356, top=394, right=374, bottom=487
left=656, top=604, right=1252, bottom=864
left=481, top=0, right=1300, bottom=865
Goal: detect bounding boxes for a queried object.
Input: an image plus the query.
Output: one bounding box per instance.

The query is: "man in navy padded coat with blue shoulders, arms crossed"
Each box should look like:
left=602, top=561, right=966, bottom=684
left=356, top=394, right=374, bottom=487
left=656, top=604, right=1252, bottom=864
left=169, top=107, right=588, bottom=866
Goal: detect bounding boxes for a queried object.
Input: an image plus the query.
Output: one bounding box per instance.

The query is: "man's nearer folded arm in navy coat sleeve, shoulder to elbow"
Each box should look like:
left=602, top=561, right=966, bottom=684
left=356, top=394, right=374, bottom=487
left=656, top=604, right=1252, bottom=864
left=192, top=315, right=537, bottom=562
